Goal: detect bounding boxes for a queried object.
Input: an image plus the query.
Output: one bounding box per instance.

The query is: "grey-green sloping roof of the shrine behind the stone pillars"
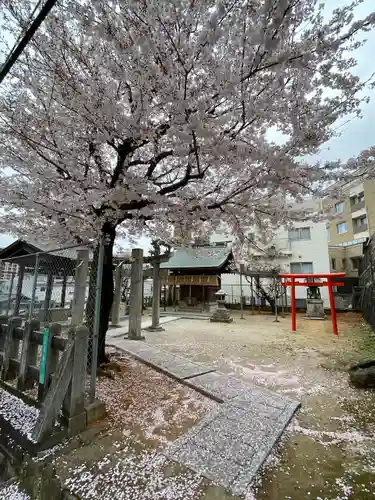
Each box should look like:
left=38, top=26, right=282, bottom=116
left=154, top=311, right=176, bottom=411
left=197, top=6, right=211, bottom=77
left=160, top=246, right=232, bottom=269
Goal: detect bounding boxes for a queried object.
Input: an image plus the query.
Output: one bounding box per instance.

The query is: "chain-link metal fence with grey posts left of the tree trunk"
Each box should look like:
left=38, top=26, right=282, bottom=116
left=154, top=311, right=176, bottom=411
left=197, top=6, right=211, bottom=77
left=0, top=242, right=104, bottom=399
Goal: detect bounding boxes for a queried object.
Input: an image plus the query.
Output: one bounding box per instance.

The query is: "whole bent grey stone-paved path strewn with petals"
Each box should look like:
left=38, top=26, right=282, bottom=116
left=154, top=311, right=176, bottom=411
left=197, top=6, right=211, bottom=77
left=111, top=337, right=299, bottom=495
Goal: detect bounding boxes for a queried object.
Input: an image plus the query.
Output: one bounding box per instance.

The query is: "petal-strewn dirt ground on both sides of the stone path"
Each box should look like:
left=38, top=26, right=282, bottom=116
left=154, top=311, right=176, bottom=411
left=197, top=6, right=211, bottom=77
left=0, top=313, right=375, bottom=500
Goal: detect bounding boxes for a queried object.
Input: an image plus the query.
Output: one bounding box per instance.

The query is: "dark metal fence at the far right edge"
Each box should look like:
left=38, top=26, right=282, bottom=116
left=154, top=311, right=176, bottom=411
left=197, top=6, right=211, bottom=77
left=359, top=236, right=375, bottom=332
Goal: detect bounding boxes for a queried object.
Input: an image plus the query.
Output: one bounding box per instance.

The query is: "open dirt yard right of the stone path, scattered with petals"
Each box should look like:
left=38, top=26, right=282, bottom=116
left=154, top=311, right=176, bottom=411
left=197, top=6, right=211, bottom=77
left=140, top=313, right=375, bottom=500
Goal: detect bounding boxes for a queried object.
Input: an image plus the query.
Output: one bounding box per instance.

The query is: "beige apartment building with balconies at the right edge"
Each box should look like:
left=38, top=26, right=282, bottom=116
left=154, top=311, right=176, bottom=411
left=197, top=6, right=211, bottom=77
left=326, top=179, right=375, bottom=278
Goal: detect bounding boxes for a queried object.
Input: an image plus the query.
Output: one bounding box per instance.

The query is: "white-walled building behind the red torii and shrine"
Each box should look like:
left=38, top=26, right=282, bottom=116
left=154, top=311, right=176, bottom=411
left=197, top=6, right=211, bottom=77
left=210, top=213, right=330, bottom=308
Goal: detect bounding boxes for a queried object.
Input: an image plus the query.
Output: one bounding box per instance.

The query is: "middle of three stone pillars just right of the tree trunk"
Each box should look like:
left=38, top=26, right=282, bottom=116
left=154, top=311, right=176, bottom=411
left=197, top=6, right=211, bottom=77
left=129, top=248, right=144, bottom=340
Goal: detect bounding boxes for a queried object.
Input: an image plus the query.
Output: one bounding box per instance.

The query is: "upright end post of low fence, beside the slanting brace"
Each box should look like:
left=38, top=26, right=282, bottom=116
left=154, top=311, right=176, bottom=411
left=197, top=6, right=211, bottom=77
left=63, top=326, right=89, bottom=435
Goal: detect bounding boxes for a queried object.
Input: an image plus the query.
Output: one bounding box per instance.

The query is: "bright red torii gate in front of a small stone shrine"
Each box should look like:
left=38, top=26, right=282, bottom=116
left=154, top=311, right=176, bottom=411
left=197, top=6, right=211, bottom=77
left=280, top=273, right=345, bottom=335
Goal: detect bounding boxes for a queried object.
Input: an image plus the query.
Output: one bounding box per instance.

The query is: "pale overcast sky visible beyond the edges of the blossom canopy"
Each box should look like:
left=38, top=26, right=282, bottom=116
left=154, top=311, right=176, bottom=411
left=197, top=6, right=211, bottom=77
left=0, top=0, right=375, bottom=248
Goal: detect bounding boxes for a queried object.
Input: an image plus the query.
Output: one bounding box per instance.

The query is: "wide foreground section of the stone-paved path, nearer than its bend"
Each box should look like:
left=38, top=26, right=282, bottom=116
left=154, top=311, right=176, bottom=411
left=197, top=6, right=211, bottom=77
left=165, top=382, right=299, bottom=495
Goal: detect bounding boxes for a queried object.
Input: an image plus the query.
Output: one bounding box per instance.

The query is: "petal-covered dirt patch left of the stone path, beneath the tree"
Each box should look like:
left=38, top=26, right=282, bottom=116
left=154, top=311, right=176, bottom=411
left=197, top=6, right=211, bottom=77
left=51, top=348, right=239, bottom=500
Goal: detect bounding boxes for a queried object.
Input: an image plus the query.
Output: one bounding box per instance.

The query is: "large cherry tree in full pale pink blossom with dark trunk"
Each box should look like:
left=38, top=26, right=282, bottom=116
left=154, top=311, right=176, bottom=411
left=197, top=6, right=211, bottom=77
left=0, top=0, right=375, bottom=360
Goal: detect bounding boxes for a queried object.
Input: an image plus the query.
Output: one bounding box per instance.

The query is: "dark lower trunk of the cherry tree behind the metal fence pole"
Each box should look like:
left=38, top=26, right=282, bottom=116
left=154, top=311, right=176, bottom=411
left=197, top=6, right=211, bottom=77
left=86, top=224, right=116, bottom=366
